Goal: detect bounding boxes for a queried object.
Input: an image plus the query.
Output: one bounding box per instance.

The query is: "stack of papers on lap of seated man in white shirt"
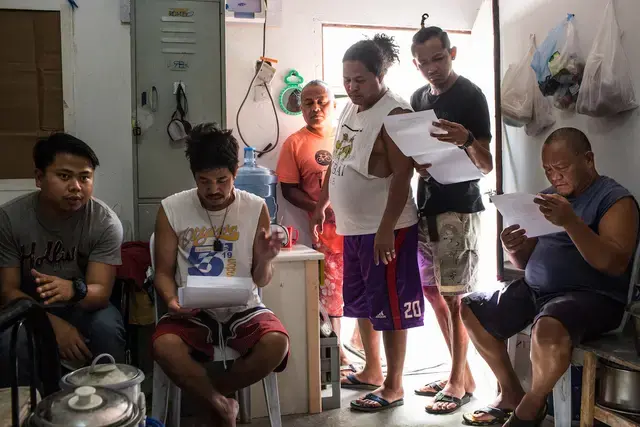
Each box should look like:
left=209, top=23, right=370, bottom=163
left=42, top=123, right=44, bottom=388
left=178, top=276, right=254, bottom=309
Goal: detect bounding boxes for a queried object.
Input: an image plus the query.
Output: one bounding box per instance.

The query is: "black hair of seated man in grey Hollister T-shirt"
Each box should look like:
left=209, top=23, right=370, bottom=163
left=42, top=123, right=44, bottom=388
left=33, top=132, right=100, bottom=171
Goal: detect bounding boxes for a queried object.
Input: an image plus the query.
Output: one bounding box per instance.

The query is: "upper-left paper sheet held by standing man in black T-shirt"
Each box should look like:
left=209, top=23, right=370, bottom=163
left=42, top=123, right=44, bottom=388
left=384, top=110, right=448, bottom=157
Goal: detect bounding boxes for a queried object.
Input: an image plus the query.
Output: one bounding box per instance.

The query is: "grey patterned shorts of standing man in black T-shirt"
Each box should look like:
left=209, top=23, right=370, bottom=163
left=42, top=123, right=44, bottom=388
left=418, top=212, right=480, bottom=296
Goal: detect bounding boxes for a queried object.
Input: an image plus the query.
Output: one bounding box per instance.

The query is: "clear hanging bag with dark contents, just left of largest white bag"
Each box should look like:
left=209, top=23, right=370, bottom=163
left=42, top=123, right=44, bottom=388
left=549, top=15, right=585, bottom=110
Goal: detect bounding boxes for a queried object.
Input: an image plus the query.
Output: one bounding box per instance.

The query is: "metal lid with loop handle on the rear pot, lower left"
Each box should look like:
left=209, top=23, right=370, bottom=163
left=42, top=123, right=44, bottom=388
left=64, top=354, right=144, bottom=387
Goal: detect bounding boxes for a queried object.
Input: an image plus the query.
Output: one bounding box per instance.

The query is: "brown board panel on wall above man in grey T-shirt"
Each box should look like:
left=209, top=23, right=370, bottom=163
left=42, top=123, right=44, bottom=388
left=0, top=10, right=64, bottom=179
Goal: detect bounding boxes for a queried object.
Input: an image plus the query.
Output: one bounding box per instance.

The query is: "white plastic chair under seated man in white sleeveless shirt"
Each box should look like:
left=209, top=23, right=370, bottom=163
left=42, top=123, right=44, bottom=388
left=149, top=234, right=282, bottom=427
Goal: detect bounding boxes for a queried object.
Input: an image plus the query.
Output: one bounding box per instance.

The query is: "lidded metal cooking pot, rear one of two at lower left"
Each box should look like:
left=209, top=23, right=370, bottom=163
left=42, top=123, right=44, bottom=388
left=60, top=353, right=147, bottom=422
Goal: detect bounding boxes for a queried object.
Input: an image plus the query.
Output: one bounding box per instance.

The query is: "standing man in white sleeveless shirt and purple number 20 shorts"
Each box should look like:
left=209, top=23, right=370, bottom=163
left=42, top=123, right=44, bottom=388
left=312, top=34, right=424, bottom=412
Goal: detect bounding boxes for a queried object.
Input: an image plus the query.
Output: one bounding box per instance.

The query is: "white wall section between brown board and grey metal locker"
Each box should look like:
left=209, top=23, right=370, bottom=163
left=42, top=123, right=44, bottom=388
left=0, top=0, right=133, bottom=227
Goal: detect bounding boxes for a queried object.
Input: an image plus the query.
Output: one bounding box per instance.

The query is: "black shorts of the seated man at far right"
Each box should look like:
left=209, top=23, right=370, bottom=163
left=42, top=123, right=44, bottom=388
left=462, top=279, right=625, bottom=346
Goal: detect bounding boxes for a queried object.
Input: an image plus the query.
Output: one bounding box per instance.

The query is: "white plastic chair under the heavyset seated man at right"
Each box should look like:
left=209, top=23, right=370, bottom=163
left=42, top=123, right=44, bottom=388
left=507, top=244, right=640, bottom=427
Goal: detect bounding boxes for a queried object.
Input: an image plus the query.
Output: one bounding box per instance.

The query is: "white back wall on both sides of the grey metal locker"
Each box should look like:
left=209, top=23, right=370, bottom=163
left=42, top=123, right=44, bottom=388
left=0, top=0, right=481, bottom=237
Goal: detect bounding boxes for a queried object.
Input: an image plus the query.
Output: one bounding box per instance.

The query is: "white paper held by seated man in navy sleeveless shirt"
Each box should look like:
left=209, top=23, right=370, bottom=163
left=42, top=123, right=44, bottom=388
left=491, top=193, right=564, bottom=237
